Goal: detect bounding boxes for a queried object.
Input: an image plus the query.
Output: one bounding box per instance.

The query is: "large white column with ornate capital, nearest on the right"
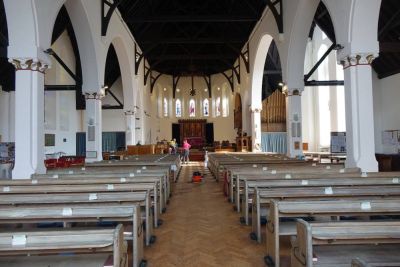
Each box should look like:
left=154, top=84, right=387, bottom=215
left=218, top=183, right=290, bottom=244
left=341, top=53, right=378, bottom=172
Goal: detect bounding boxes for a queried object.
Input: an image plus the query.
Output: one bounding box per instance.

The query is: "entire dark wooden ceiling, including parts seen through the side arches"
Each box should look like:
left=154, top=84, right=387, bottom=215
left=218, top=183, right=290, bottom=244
left=0, top=0, right=400, bottom=94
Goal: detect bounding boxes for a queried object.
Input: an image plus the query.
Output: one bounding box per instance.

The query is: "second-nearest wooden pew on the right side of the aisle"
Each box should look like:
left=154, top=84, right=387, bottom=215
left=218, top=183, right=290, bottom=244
left=265, top=200, right=400, bottom=266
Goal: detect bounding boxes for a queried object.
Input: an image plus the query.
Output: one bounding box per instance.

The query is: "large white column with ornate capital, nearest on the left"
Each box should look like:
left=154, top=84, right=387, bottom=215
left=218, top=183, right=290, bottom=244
left=9, top=58, right=48, bottom=179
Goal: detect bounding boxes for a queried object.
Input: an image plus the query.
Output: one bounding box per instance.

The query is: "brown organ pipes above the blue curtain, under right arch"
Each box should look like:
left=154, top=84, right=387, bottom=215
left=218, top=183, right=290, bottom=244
left=261, top=90, right=286, bottom=132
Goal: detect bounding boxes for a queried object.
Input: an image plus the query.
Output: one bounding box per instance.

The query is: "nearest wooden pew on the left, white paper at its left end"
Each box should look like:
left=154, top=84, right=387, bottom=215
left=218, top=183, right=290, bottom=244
left=0, top=225, right=127, bottom=267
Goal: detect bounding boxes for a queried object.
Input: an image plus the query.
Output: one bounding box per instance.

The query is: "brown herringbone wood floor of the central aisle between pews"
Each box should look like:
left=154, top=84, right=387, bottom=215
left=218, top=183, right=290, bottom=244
left=145, top=162, right=266, bottom=267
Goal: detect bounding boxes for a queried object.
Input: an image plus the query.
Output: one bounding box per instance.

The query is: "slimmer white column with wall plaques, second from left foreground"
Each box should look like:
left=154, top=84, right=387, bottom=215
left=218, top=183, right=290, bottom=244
left=85, top=92, right=104, bottom=162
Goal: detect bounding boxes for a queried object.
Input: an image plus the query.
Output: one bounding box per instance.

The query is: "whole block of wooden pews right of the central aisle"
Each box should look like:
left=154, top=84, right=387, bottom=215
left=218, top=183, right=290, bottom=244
left=209, top=153, right=400, bottom=267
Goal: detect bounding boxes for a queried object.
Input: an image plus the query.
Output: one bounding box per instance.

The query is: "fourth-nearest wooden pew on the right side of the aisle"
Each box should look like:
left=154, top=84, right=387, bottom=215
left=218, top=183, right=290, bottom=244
left=241, top=175, right=400, bottom=225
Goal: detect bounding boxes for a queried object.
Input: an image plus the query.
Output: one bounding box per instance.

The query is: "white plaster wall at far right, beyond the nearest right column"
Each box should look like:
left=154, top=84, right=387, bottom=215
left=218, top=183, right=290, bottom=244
left=372, top=72, right=400, bottom=153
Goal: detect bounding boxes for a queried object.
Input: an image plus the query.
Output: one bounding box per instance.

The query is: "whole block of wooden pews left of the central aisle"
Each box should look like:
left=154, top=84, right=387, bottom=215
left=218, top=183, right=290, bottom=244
left=0, top=155, right=180, bottom=267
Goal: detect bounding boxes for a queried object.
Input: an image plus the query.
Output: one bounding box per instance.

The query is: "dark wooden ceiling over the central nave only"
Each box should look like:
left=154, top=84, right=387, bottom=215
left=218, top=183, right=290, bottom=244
left=118, top=0, right=267, bottom=75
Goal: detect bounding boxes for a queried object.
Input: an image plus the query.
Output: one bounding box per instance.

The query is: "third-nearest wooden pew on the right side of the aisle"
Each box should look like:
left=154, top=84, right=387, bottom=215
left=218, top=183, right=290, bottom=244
left=251, top=185, right=400, bottom=245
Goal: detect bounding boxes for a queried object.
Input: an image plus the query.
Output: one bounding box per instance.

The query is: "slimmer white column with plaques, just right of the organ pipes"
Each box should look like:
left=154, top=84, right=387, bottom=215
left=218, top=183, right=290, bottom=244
left=284, top=89, right=303, bottom=158
